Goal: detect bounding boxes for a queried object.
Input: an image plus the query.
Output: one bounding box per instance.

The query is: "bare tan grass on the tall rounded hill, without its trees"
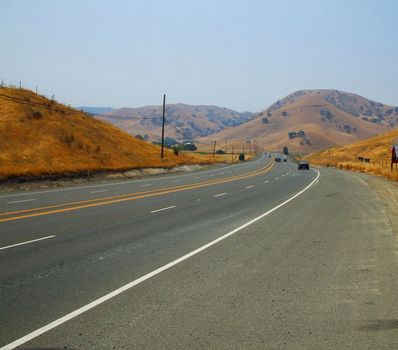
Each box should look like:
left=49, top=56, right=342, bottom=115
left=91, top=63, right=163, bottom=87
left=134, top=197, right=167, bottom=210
left=197, top=90, right=390, bottom=153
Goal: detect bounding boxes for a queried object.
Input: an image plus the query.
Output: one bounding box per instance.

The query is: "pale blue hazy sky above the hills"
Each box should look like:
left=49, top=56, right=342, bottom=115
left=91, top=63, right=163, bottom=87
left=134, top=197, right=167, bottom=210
left=0, top=0, right=398, bottom=112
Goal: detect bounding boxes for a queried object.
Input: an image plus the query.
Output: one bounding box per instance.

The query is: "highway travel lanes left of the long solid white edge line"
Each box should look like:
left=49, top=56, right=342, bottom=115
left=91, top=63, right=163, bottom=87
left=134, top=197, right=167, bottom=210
left=0, top=157, right=316, bottom=343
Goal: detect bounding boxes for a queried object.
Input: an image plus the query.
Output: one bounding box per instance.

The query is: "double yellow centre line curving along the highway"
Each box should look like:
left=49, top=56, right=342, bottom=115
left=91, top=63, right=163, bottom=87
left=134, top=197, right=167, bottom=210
left=0, top=161, right=274, bottom=223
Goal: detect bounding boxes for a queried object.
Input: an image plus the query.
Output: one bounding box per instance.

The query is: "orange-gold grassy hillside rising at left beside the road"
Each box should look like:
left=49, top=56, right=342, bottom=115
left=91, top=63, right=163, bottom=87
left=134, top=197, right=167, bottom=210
left=0, top=88, right=221, bottom=179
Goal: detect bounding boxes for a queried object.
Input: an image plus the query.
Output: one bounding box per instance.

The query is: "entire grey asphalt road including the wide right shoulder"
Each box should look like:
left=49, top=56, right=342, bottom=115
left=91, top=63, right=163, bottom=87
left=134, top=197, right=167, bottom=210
left=0, top=157, right=398, bottom=349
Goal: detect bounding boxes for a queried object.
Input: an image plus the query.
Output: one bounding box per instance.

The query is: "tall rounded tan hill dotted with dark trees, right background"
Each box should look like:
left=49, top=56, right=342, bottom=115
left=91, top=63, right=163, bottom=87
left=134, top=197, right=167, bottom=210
left=198, top=90, right=398, bottom=152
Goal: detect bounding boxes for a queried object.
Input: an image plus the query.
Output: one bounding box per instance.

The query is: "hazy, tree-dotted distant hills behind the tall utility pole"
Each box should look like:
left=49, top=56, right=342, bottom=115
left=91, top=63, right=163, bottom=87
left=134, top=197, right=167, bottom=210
left=95, top=103, right=253, bottom=140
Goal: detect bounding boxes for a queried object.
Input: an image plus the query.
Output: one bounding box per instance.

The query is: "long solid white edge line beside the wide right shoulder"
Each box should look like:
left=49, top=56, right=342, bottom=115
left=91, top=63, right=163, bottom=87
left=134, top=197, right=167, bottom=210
left=0, top=169, right=320, bottom=350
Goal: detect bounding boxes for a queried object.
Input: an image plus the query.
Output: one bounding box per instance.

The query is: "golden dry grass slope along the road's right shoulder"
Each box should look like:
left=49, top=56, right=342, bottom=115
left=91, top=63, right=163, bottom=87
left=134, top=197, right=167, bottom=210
left=305, top=129, right=398, bottom=181
